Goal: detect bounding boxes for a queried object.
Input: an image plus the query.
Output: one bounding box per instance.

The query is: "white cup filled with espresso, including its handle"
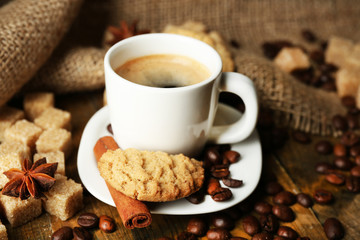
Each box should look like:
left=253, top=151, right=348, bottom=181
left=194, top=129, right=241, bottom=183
left=104, top=33, right=258, bottom=156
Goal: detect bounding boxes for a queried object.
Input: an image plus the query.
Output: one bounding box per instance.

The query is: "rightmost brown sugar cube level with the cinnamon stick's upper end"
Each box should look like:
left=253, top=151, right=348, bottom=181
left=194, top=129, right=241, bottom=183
left=36, top=128, right=72, bottom=157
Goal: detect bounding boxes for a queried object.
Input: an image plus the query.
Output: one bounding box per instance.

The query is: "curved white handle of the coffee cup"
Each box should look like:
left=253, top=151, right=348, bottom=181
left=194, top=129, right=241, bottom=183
left=209, top=72, right=259, bottom=144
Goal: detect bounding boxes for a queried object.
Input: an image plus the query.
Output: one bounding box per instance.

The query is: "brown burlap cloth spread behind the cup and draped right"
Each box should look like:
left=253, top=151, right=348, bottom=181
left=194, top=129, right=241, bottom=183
left=0, top=0, right=360, bottom=135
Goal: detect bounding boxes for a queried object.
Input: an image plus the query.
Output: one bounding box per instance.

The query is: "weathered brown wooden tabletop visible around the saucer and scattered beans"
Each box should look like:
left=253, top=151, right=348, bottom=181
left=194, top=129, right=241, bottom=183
left=7, top=90, right=360, bottom=240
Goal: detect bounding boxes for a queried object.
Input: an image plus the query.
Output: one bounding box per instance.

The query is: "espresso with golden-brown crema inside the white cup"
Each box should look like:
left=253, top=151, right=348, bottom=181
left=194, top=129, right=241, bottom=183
left=115, top=54, right=210, bottom=88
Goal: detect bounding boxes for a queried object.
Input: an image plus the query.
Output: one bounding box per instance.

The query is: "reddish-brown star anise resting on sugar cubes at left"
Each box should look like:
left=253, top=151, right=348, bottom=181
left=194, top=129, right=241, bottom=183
left=1, top=158, right=58, bottom=200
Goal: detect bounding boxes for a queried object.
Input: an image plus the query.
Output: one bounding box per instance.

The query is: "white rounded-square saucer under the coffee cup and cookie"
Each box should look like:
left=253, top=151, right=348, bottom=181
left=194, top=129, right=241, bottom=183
left=77, top=104, right=262, bottom=215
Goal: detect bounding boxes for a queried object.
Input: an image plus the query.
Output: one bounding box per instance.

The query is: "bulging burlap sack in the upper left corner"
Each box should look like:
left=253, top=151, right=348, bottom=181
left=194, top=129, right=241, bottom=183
left=0, top=0, right=82, bottom=106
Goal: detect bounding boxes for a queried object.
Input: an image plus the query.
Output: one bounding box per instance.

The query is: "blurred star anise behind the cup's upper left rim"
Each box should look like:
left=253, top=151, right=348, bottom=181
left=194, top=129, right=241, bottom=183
left=107, top=21, right=150, bottom=45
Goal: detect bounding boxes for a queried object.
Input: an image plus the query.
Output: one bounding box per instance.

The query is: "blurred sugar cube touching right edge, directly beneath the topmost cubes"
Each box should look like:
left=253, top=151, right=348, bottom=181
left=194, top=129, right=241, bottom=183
left=335, top=68, right=360, bottom=97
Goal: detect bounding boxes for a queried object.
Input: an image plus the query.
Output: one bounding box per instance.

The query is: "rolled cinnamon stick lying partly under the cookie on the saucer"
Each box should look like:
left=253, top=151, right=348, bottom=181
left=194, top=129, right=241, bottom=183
left=94, top=136, right=152, bottom=229
